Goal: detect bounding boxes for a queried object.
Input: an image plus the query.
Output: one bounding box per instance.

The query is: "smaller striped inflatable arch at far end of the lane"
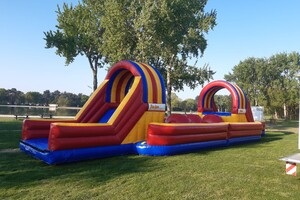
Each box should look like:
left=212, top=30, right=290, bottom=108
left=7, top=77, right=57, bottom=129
left=198, top=80, right=254, bottom=122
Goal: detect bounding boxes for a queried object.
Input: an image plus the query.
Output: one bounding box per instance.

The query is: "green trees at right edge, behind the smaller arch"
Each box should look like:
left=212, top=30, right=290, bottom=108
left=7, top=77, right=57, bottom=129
left=224, top=52, right=300, bottom=118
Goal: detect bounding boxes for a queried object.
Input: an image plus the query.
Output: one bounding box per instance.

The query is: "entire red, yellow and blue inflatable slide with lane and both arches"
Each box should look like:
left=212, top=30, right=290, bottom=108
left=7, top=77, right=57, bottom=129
left=20, top=61, right=264, bottom=164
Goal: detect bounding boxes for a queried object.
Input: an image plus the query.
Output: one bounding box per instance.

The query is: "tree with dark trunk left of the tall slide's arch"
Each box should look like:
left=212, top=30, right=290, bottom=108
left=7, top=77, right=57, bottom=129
left=44, top=1, right=105, bottom=90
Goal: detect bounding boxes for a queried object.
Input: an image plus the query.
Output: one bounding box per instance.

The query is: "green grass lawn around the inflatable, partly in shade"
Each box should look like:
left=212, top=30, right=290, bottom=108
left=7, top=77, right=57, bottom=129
left=0, top=119, right=300, bottom=199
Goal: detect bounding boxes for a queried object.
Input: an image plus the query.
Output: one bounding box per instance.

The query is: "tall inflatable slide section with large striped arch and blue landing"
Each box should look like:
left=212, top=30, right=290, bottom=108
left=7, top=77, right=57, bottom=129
left=20, top=61, right=165, bottom=164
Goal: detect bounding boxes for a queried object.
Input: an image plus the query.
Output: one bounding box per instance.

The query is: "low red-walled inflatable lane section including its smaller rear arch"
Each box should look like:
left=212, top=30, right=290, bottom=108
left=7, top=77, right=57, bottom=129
left=137, top=81, right=264, bottom=155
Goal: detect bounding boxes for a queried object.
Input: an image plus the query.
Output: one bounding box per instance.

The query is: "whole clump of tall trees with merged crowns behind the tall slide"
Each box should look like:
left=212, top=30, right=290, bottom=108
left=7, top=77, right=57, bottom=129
left=45, top=0, right=216, bottom=114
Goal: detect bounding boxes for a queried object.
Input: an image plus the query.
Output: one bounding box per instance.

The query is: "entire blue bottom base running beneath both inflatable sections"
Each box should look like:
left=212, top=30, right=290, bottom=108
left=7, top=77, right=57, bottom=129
left=20, top=136, right=261, bottom=165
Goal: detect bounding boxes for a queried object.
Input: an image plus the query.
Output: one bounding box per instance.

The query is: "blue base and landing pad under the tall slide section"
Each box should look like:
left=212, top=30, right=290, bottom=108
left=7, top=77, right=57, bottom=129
left=20, top=138, right=136, bottom=165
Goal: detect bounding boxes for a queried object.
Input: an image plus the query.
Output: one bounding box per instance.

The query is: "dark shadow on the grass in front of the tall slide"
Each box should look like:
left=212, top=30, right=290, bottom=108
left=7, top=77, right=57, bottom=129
left=0, top=152, right=161, bottom=189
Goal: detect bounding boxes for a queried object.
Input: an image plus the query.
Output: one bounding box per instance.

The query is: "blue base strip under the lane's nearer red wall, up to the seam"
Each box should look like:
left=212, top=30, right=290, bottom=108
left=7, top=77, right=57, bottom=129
left=136, top=140, right=227, bottom=156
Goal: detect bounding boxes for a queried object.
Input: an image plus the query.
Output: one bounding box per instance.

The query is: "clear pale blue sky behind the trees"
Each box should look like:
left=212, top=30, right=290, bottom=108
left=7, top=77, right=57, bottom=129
left=0, top=0, right=300, bottom=100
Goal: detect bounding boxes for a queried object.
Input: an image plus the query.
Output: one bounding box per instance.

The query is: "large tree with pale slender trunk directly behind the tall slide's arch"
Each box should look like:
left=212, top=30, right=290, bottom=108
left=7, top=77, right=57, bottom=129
left=98, top=0, right=216, bottom=114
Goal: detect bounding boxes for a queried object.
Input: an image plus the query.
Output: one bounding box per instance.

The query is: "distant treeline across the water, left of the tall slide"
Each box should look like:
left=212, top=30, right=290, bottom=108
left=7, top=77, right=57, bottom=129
left=0, top=88, right=89, bottom=107
